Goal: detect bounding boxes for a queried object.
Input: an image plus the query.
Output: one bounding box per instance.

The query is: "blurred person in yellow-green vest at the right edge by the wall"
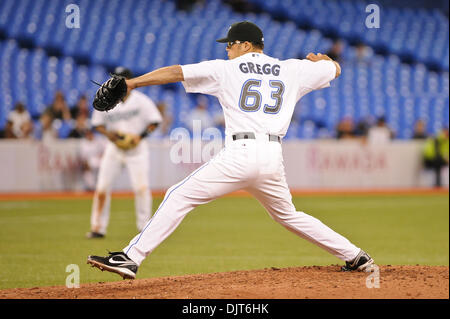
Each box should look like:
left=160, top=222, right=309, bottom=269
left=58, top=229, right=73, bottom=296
left=423, top=128, right=449, bottom=187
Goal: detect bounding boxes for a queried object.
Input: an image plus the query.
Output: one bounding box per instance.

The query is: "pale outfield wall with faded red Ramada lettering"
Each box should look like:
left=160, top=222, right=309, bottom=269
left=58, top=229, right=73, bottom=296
left=0, top=139, right=448, bottom=192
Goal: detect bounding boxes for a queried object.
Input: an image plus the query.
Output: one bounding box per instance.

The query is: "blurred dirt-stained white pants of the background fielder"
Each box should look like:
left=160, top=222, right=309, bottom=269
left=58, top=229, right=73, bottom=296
left=91, top=141, right=152, bottom=234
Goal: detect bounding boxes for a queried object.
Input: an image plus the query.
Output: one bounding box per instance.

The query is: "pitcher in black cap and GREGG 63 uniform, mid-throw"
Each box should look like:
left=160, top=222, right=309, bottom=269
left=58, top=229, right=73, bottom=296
left=88, top=21, right=373, bottom=279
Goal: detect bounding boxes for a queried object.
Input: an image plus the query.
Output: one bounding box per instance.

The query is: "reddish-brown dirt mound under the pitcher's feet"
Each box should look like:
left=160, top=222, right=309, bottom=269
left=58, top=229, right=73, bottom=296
left=0, top=265, right=449, bottom=299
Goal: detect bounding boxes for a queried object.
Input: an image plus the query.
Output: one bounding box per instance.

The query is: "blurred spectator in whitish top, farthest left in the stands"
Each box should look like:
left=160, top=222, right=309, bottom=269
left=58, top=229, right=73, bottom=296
left=5, top=102, right=33, bottom=138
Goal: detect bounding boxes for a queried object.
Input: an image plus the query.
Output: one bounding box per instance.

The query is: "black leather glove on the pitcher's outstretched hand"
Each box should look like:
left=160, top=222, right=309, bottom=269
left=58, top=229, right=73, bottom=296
left=92, top=75, right=127, bottom=112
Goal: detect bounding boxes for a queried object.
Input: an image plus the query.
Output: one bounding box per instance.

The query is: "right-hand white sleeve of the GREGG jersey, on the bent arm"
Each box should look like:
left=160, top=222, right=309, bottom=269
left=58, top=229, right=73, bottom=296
left=298, top=59, right=336, bottom=90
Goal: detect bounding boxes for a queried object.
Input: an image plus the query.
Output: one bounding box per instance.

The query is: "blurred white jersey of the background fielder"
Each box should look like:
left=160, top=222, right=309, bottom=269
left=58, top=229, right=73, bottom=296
left=92, top=90, right=162, bottom=135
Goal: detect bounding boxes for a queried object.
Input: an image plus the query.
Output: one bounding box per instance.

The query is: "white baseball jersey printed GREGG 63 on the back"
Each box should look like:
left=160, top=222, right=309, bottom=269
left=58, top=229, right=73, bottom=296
left=182, top=52, right=336, bottom=137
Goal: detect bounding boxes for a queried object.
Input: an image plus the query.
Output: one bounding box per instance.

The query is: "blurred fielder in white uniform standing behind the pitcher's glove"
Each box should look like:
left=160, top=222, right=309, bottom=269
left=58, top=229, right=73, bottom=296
left=86, top=67, right=162, bottom=238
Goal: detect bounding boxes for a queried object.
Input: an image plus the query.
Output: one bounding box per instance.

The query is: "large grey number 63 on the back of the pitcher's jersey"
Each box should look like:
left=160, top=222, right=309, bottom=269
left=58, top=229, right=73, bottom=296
left=239, top=79, right=284, bottom=114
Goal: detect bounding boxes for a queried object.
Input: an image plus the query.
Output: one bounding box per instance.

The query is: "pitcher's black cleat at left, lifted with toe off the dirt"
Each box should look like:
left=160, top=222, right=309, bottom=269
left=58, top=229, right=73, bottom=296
left=87, top=251, right=138, bottom=279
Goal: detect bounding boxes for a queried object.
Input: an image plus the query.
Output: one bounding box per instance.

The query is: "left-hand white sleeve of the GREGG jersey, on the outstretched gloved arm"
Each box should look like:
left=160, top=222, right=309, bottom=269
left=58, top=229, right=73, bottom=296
left=181, top=60, right=225, bottom=95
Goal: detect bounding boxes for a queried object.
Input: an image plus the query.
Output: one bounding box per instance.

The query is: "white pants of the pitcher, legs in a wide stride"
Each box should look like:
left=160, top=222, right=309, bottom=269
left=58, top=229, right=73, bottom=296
left=123, top=135, right=360, bottom=265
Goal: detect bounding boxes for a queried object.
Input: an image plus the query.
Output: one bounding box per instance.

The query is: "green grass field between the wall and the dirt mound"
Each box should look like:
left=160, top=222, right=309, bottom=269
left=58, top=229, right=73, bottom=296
left=0, top=195, right=449, bottom=289
